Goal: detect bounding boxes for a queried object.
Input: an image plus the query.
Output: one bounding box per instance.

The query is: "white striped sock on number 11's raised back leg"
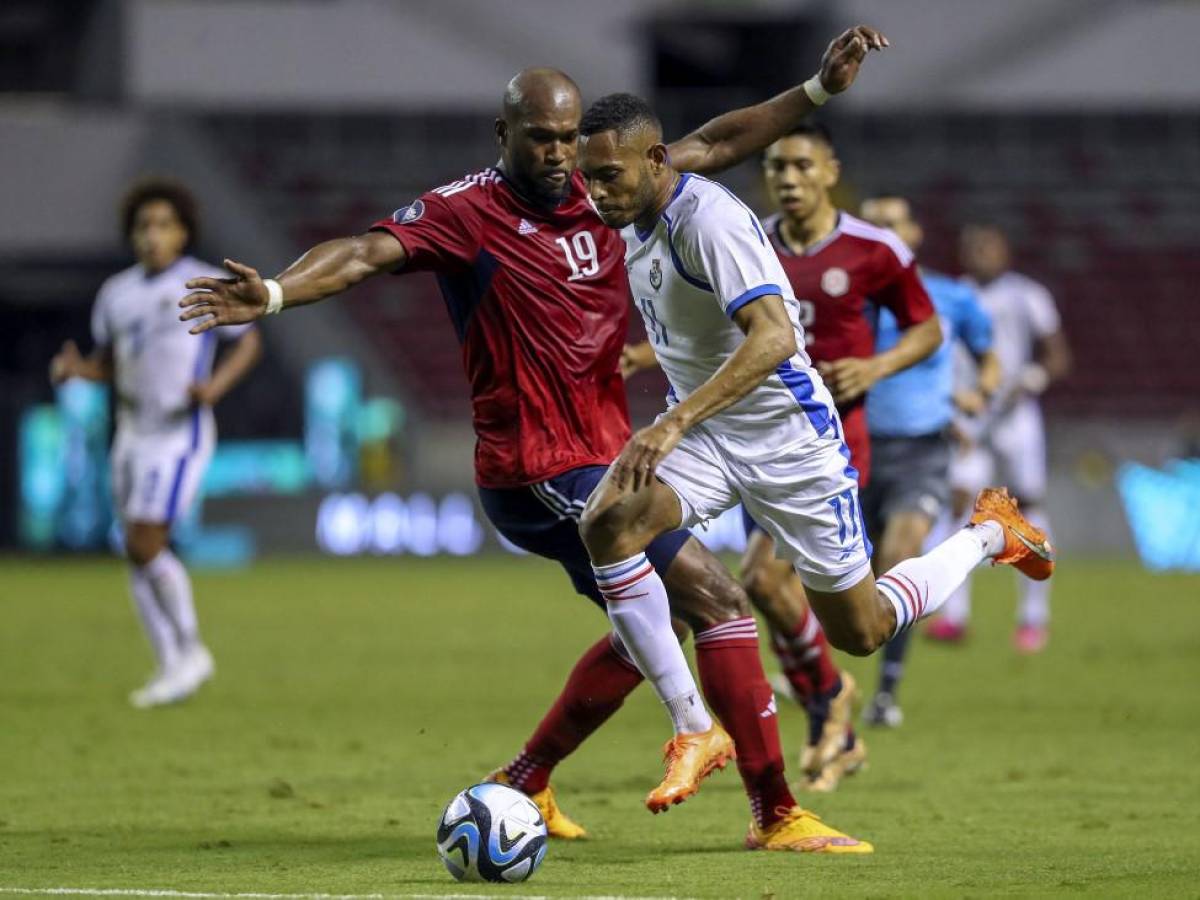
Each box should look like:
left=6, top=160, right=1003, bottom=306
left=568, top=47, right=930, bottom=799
left=876, top=522, right=1004, bottom=637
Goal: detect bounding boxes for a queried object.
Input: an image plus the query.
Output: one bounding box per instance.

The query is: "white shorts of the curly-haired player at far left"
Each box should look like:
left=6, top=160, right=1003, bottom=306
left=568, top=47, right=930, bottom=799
left=112, top=415, right=216, bottom=524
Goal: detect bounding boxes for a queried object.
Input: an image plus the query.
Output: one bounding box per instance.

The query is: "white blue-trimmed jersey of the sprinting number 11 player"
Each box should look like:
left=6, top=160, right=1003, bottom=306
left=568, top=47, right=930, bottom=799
left=622, top=175, right=836, bottom=461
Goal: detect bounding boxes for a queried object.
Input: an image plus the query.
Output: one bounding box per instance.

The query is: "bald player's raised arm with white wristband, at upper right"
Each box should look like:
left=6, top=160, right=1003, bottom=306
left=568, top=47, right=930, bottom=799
left=667, top=25, right=888, bottom=175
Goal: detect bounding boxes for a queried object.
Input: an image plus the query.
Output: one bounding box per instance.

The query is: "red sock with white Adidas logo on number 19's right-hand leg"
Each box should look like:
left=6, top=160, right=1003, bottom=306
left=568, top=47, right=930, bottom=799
left=696, top=617, right=796, bottom=826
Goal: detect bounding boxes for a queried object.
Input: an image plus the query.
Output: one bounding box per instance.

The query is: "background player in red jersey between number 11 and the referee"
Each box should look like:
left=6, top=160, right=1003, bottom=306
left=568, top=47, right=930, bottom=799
left=742, top=125, right=942, bottom=790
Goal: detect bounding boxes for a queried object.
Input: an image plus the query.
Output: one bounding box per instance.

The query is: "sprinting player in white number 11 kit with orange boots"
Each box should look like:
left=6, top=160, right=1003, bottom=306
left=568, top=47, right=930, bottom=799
left=580, top=94, right=1052, bottom=830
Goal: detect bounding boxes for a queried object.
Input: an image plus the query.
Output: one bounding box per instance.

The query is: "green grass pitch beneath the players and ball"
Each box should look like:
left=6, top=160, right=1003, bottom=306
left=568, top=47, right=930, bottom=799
left=0, top=558, right=1200, bottom=900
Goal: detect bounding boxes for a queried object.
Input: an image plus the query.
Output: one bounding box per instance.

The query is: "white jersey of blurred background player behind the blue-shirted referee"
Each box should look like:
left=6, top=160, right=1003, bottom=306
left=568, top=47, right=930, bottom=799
left=967, top=271, right=1060, bottom=409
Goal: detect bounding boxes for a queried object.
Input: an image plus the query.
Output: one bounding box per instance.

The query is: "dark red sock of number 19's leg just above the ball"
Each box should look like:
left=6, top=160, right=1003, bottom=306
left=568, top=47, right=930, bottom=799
left=504, top=635, right=642, bottom=794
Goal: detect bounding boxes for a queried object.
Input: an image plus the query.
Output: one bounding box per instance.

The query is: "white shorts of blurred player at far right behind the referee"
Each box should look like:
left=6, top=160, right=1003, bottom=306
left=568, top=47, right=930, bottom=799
left=950, top=397, right=1046, bottom=504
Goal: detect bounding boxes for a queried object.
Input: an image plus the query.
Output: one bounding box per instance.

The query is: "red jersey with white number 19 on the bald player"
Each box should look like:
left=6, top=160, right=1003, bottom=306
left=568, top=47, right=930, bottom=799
left=373, top=168, right=630, bottom=487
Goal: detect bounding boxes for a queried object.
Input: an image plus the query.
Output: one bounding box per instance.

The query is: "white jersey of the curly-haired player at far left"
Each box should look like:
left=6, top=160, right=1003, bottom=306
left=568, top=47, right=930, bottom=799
left=91, top=257, right=247, bottom=440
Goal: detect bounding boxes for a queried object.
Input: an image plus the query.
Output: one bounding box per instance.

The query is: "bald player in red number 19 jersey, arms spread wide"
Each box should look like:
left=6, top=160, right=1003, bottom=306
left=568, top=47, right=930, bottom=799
left=180, top=28, right=886, bottom=851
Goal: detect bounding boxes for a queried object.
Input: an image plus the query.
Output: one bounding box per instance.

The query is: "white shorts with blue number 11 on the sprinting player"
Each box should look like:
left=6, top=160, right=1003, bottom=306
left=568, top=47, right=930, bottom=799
left=658, top=426, right=871, bottom=593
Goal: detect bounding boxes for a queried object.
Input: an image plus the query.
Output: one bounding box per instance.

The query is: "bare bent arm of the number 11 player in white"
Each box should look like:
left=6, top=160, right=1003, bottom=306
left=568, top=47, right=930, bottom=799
left=612, top=294, right=796, bottom=491
